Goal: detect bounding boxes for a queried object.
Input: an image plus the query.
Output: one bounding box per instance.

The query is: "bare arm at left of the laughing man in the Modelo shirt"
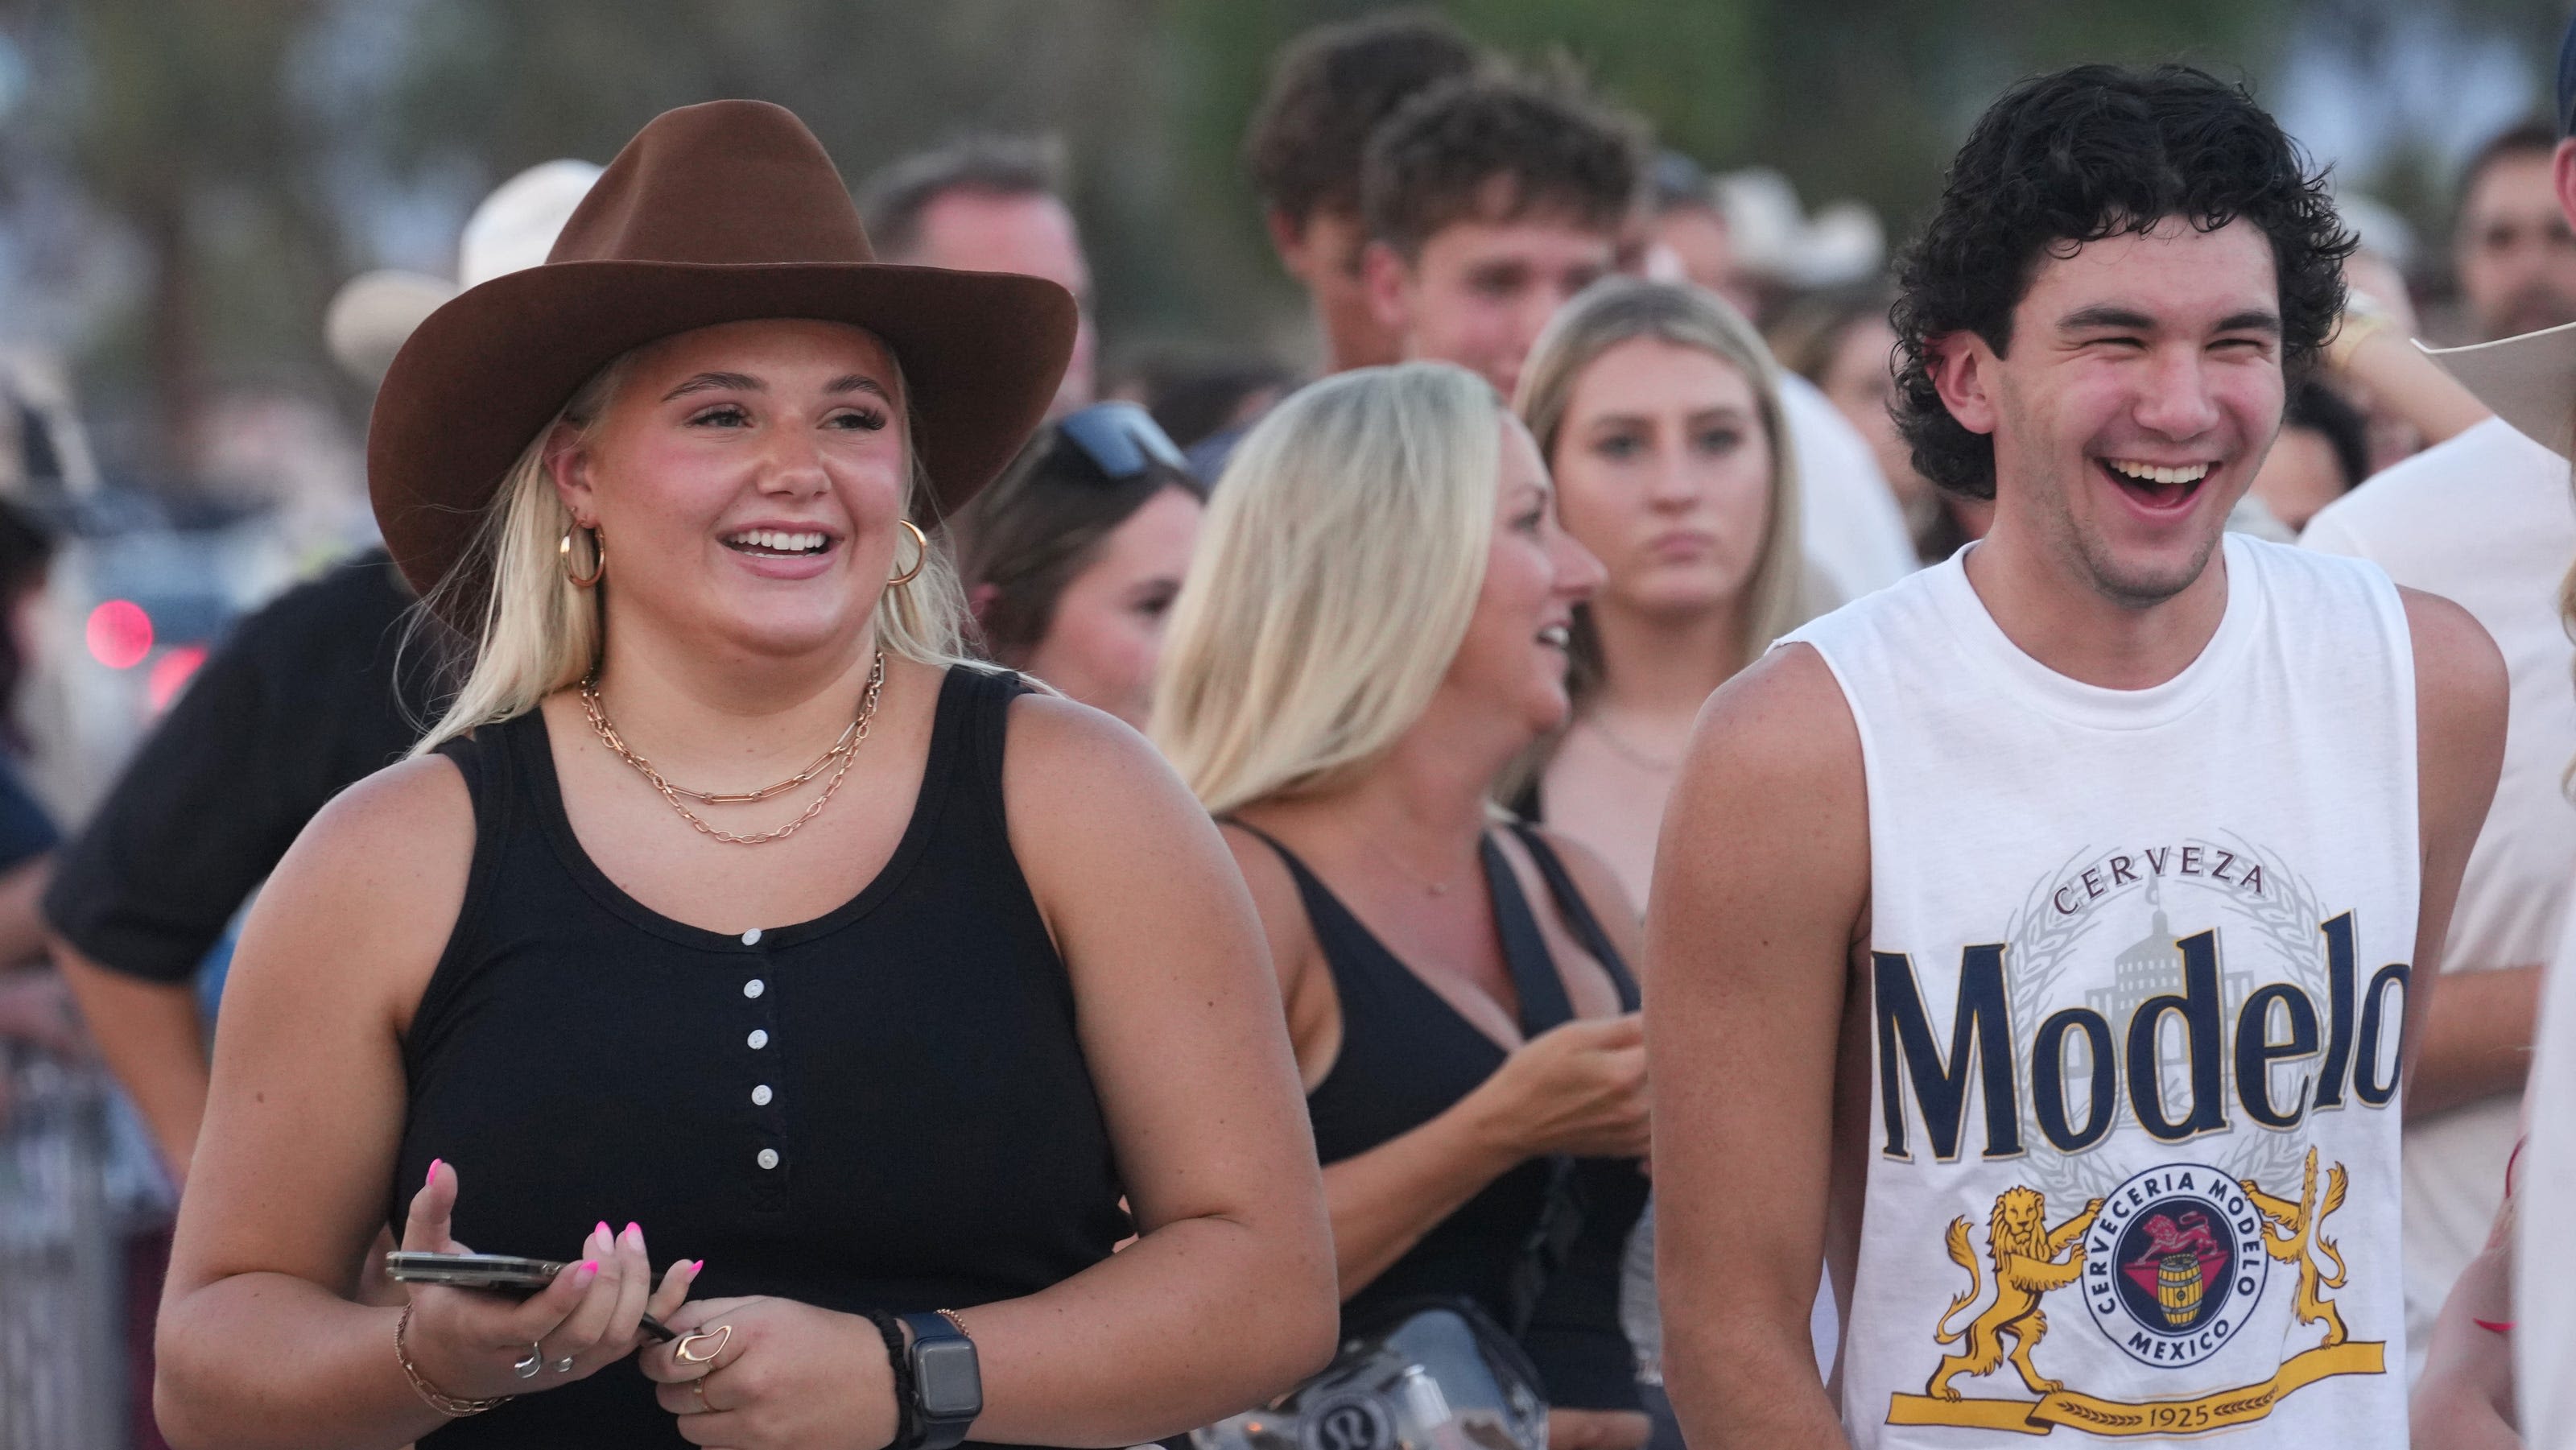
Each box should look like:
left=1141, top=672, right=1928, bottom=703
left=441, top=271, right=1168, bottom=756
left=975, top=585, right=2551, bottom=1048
left=1646, top=647, right=1870, bottom=1450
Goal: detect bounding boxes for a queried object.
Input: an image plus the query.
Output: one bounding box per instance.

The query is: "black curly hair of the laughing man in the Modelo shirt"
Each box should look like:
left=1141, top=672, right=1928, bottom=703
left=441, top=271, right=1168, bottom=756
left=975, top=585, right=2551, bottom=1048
left=1891, top=64, right=2355, bottom=500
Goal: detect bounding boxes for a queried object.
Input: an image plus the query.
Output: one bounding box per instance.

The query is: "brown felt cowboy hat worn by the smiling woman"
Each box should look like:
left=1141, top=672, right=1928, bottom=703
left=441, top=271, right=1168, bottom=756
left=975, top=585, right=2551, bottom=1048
left=365, top=101, right=1077, bottom=620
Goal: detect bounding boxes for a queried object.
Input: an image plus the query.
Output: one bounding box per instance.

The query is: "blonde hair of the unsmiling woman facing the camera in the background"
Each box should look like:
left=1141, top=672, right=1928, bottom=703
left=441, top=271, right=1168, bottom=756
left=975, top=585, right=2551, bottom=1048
left=1512, top=275, right=1806, bottom=708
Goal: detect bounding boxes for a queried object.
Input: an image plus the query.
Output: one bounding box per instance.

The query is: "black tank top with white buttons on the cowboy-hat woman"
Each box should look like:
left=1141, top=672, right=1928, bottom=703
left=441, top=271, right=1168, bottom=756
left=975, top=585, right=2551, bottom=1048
left=386, top=667, right=1131, bottom=1450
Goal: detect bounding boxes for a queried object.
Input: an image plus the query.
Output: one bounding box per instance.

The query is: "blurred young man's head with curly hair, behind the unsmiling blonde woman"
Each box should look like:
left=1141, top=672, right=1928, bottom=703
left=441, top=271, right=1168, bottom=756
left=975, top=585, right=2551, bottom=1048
left=1360, top=72, right=1644, bottom=397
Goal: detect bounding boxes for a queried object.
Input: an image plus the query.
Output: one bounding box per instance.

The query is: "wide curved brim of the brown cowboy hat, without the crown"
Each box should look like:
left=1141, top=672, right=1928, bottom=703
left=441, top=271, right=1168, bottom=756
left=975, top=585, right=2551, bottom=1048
left=365, top=260, right=1080, bottom=623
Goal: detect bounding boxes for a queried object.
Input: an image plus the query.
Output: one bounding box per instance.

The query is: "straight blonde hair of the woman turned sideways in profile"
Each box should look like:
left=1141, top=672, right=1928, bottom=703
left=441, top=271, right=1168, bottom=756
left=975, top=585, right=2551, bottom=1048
left=1154, top=363, right=1505, bottom=816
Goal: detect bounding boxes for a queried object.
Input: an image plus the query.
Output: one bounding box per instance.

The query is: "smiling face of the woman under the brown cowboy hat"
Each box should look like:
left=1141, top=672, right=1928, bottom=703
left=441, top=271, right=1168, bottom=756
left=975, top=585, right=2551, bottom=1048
left=546, top=320, right=912, bottom=657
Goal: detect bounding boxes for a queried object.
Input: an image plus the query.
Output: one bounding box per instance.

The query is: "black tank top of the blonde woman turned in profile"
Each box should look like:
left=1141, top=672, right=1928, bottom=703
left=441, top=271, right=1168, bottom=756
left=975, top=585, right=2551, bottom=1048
left=1236, top=821, right=1646, bottom=1409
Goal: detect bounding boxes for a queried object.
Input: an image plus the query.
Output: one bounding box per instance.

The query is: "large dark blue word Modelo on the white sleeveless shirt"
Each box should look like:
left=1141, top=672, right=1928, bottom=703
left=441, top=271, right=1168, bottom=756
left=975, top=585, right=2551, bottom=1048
left=1870, top=911, right=2409, bottom=1162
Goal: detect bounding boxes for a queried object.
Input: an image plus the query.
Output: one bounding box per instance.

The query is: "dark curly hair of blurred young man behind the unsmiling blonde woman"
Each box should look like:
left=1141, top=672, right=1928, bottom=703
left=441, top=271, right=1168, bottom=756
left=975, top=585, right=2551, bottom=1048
left=1360, top=72, right=1646, bottom=260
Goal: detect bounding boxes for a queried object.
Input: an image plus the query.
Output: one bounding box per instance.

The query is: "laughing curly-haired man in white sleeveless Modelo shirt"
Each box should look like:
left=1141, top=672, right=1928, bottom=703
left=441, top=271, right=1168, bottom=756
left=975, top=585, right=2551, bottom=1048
left=1649, top=67, right=2504, bottom=1450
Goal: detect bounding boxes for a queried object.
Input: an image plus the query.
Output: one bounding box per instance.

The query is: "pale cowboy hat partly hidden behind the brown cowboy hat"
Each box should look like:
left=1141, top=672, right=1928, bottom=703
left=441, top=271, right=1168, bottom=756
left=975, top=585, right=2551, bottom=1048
left=322, top=159, right=601, bottom=386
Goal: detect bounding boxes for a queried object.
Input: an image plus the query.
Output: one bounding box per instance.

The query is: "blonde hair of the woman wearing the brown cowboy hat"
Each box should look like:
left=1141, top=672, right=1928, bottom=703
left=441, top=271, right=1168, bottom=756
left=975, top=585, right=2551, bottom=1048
left=412, top=353, right=966, bottom=754
